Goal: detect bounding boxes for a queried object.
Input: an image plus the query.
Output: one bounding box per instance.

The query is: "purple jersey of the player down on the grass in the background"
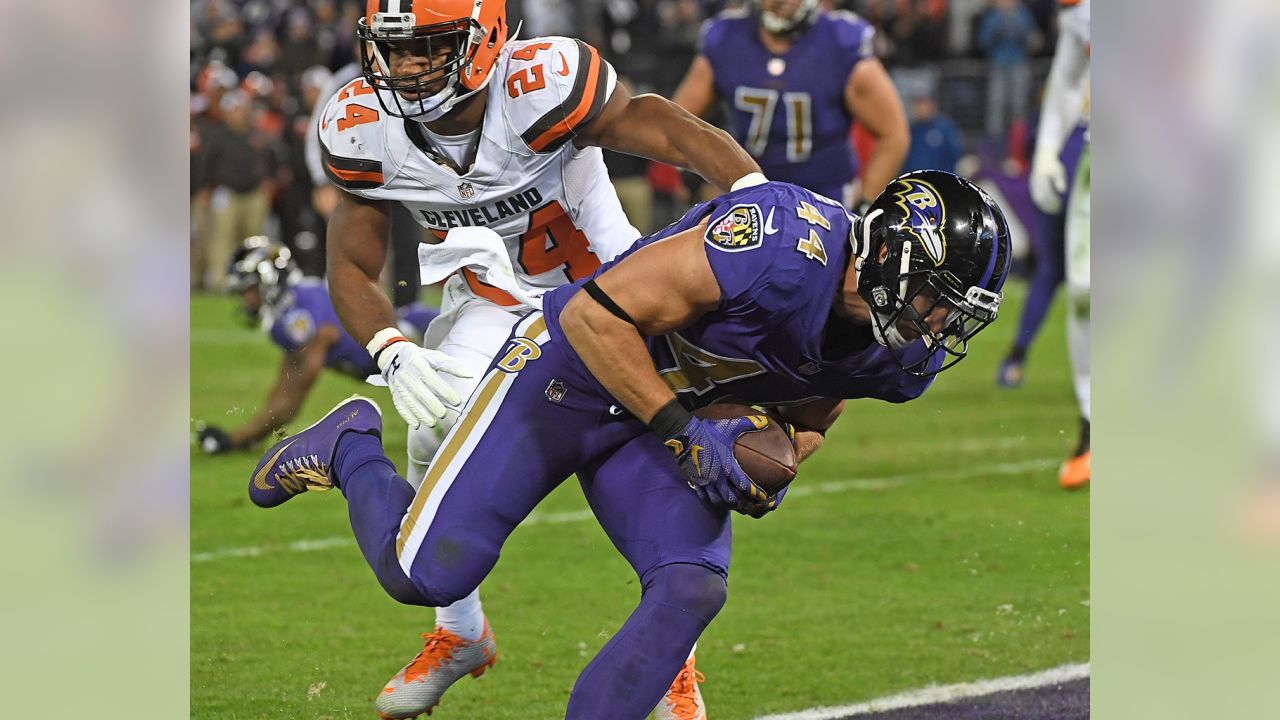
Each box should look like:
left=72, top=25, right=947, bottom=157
left=263, top=278, right=378, bottom=379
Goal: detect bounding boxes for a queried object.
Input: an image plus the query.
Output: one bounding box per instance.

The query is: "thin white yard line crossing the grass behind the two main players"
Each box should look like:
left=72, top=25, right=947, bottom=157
left=191, top=459, right=1059, bottom=562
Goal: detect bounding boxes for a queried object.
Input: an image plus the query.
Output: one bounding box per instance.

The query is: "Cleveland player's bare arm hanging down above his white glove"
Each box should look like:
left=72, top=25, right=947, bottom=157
left=326, top=192, right=396, bottom=345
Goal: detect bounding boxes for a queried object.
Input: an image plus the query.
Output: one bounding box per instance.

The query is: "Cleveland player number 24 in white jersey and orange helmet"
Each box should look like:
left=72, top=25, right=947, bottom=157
left=308, top=0, right=764, bottom=719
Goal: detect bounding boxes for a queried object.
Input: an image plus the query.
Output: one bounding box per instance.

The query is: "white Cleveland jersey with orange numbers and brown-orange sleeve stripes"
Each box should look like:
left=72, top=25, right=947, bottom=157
left=317, top=37, right=640, bottom=306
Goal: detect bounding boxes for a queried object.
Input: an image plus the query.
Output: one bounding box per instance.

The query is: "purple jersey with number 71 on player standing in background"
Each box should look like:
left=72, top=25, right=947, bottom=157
left=701, top=12, right=876, bottom=201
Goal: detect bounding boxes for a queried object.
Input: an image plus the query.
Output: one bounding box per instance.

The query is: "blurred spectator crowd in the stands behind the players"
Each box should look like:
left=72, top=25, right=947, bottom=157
left=191, top=0, right=1056, bottom=290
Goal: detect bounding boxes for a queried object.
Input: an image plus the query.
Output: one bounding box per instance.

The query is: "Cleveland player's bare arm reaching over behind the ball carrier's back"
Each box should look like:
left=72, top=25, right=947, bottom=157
left=576, top=82, right=757, bottom=191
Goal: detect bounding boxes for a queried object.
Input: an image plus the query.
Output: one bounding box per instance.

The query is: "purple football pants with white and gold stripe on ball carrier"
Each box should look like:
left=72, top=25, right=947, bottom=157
left=335, top=313, right=731, bottom=720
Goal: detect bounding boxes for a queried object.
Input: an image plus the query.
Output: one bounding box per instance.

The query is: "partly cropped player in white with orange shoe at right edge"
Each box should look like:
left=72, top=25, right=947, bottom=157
left=1030, top=0, right=1089, bottom=489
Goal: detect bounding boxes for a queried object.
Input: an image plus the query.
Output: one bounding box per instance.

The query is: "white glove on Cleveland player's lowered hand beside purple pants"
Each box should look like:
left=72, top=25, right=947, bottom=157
left=378, top=340, right=472, bottom=428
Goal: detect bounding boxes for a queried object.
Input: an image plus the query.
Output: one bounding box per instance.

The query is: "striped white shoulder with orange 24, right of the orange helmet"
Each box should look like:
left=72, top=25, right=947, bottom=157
left=501, top=37, right=617, bottom=152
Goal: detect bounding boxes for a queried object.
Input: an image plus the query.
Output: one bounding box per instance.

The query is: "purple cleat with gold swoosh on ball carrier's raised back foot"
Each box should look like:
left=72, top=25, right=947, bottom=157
left=248, top=395, right=383, bottom=507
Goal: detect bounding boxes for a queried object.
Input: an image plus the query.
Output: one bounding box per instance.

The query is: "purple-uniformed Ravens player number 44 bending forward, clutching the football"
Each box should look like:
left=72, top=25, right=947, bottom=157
left=250, top=170, right=1010, bottom=720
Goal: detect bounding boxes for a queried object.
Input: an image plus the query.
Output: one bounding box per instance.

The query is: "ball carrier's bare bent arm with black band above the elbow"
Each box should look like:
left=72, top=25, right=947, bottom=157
left=561, top=223, right=719, bottom=423
